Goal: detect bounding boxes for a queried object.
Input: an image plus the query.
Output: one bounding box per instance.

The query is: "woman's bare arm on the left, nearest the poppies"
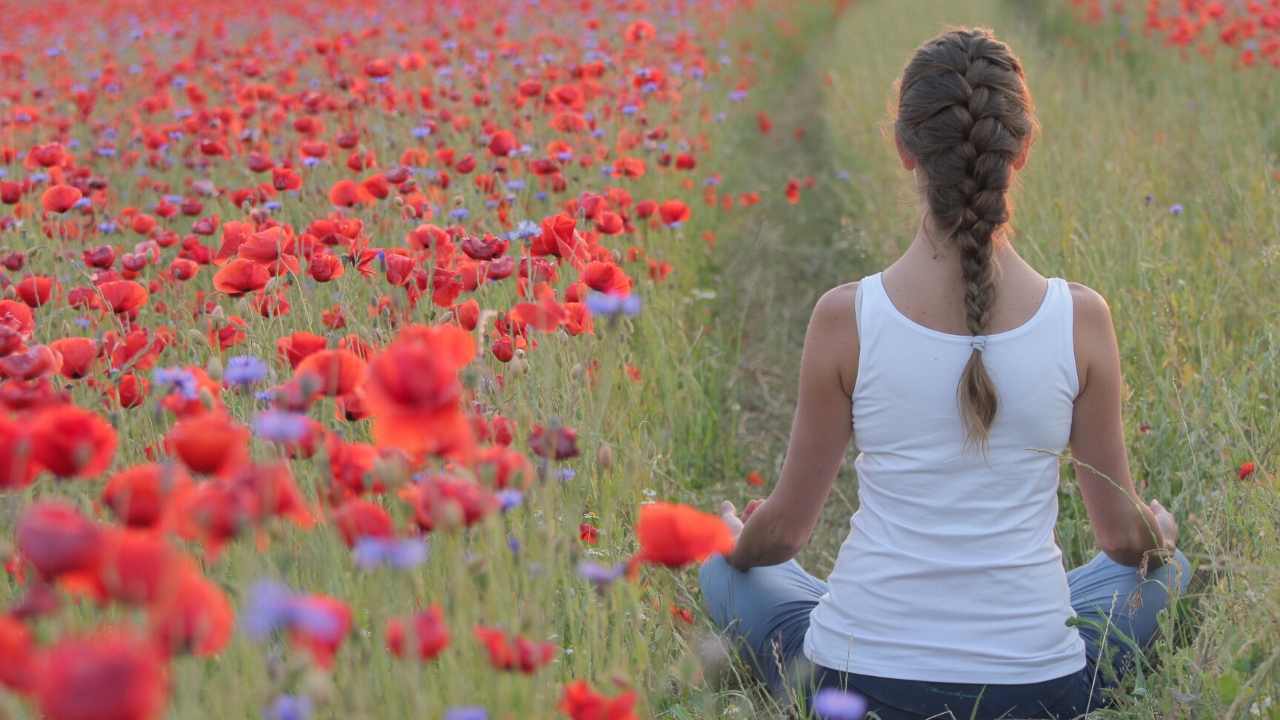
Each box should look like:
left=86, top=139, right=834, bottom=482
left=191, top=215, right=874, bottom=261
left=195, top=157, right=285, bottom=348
left=726, top=283, right=858, bottom=571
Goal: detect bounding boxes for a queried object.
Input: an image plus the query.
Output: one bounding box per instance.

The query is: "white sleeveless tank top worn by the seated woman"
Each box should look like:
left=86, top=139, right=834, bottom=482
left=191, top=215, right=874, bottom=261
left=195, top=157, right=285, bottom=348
left=804, top=273, right=1084, bottom=684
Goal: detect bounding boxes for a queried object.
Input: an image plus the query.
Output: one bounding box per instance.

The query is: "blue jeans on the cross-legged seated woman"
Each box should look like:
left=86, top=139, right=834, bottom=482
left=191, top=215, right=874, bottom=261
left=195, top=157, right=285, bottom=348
left=699, top=551, right=1190, bottom=720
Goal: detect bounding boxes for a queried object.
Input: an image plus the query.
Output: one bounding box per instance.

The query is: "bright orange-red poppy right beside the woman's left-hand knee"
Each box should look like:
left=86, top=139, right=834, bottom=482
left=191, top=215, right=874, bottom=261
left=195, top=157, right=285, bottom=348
left=636, top=502, right=733, bottom=568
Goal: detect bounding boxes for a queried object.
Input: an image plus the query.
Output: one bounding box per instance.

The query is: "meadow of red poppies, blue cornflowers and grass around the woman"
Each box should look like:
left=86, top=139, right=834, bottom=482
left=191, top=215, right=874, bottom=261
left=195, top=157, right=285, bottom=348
left=0, top=0, right=1280, bottom=720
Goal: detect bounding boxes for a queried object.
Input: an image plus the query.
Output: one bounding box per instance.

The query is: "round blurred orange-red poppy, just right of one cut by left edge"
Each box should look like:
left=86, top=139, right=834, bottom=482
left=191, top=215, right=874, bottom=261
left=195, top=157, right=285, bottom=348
left=31, top=405, right=116, bottom=478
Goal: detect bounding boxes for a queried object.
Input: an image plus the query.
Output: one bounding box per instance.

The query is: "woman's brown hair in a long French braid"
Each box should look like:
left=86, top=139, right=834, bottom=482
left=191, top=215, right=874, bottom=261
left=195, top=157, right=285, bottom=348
left=893, top=28, right=1037, bottom=447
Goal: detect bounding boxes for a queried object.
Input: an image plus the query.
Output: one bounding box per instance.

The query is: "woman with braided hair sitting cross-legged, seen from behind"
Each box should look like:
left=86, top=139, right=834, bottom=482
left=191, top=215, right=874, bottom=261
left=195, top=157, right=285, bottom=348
left=700, top=29, right=1190, bottom=720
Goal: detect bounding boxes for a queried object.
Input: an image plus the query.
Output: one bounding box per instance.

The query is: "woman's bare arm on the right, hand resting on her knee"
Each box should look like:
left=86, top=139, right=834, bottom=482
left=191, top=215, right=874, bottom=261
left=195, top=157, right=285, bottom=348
left=1070, top=283, right=1178, bottom=570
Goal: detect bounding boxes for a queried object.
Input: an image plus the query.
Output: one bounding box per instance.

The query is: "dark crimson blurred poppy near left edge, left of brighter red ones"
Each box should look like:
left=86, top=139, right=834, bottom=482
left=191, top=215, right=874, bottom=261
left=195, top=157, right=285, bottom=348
left=14, top=502, right=102, bottom=580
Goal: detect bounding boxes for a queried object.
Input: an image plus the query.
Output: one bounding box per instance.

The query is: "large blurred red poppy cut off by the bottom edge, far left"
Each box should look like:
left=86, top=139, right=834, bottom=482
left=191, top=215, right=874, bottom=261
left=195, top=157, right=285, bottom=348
left=32, top=629, right=168, bottom=720
